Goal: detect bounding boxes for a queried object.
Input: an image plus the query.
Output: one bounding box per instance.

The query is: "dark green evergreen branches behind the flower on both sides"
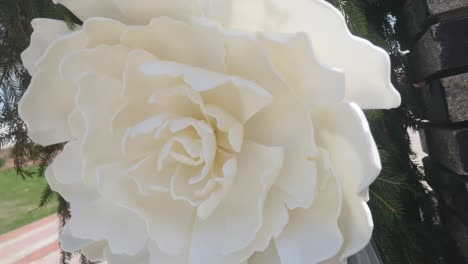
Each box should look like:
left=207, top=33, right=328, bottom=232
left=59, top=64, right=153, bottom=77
left=0, top=0, right=454, bottom=264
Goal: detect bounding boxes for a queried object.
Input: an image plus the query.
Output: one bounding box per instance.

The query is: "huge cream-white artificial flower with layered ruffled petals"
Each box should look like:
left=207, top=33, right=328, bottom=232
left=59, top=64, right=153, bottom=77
left=19, top=0, right=400, bottom=264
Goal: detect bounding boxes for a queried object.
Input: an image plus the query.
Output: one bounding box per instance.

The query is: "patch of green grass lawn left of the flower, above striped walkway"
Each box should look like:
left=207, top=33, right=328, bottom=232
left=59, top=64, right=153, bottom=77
left=0, top=169, right=57, bottom=234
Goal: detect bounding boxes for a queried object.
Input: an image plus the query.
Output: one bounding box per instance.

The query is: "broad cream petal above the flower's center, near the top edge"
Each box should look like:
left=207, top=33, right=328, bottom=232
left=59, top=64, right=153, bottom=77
left=121, top=16, right=225, bottom=72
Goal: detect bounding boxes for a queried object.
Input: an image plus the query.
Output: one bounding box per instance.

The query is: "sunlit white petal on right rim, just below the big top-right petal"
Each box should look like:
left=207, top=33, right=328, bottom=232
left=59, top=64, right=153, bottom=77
left=313, top=103, right=381, bottom=199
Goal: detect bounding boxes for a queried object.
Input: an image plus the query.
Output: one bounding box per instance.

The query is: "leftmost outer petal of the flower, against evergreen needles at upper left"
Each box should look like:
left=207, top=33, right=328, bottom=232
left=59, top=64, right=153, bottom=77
left=18, top=31, right=89, bottom=145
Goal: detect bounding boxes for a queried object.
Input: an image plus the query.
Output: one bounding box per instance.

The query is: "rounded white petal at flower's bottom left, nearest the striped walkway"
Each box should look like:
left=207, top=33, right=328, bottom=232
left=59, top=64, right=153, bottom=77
left=68, top=199, right=148, bottom=255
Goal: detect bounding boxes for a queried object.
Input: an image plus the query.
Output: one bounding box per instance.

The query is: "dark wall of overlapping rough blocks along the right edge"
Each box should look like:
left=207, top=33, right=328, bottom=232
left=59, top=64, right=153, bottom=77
left=405, top=0, right=468, bottom=264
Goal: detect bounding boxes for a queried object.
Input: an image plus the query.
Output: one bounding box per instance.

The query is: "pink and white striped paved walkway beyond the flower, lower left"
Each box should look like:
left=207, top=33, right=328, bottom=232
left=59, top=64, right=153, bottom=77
left=0, top=215, right=78, bottom=264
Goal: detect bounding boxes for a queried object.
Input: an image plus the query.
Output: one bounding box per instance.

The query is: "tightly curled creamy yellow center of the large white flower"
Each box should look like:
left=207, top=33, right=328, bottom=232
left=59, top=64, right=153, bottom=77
left=130, top=84, right=243, bottom=218
